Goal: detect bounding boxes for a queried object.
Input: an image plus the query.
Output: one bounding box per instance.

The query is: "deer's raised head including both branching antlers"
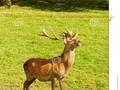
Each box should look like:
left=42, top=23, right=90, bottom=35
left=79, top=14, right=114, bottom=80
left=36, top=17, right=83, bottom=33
left=38, top=28, right=81, bottom=50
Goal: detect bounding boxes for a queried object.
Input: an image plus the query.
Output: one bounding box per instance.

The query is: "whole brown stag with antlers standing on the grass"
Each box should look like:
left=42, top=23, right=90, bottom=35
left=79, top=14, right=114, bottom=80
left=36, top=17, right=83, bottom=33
left=23, top=28, right=81, bottom=90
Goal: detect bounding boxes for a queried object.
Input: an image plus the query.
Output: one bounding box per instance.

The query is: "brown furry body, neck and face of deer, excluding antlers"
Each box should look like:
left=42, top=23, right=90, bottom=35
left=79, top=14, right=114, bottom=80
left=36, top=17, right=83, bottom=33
left=24, top=29, right=80, bottom=90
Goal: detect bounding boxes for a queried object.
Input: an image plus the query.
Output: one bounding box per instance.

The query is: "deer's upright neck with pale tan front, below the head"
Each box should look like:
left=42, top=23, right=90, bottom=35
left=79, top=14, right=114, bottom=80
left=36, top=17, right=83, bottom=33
left=61, top=48, right=75, bottom=70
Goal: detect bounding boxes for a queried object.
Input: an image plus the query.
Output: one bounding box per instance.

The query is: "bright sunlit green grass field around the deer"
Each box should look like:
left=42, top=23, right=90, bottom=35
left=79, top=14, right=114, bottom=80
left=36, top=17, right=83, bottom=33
left=0, top=5, right=109, bottom=90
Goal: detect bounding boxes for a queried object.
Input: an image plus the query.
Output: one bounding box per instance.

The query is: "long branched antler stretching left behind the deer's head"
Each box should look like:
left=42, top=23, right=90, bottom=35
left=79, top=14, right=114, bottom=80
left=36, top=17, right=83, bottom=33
left=38, top=27, right=63, bottom=40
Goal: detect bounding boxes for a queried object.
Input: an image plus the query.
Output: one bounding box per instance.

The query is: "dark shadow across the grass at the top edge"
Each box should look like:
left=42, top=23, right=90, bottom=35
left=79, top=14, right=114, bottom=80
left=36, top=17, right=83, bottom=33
left=14, top=0, right=108, bottom=12
